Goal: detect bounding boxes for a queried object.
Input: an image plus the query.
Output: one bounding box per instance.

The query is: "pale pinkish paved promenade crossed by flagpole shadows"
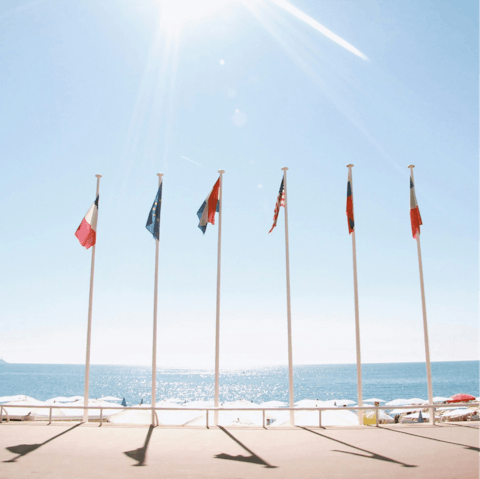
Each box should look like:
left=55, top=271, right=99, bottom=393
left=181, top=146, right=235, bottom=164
left=0, top=423, right=480, bottom=479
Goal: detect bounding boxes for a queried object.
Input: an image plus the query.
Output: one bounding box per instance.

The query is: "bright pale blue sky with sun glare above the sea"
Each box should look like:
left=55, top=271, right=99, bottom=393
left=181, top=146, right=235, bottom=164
left=0, top=0, right=480, bottom=368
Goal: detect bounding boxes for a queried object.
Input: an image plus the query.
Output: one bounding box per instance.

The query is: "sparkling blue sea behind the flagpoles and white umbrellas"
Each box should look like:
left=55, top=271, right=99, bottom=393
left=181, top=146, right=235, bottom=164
left=0, top=361, right=480, bottom=406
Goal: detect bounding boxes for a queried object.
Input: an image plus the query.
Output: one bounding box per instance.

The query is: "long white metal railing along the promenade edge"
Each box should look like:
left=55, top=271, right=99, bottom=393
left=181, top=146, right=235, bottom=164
left=0, top=402, right=480, bottom=429
